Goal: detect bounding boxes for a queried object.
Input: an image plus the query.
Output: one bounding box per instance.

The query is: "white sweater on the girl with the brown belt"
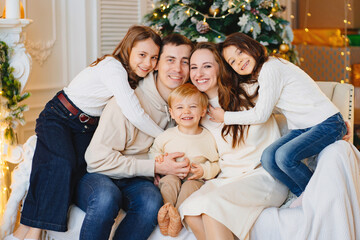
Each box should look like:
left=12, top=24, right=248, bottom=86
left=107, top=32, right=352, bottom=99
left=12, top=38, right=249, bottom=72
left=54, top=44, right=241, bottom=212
left=64, top=57, right=163, bottom=137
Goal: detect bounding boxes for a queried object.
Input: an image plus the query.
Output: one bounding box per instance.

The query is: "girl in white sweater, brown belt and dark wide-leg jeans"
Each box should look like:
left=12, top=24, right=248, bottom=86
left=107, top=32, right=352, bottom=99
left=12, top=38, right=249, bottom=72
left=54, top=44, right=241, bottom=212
left=6, top=26, right=163, bottom=240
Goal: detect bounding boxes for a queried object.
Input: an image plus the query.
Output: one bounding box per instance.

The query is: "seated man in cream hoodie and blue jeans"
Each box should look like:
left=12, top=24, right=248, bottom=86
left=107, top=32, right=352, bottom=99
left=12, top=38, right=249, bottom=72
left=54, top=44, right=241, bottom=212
left=76, top=34, right=192, bottom=240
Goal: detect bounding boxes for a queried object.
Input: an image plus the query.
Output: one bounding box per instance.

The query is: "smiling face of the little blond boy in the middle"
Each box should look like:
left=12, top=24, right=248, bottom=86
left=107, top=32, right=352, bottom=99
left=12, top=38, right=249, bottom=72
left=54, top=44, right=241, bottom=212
left=169, top=94, right=206, bottom=129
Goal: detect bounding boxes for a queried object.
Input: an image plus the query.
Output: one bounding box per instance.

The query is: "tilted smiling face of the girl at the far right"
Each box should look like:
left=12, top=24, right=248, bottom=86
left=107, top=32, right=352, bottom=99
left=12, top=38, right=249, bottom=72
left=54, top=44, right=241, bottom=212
left=222, top=45, right=256, bottom=75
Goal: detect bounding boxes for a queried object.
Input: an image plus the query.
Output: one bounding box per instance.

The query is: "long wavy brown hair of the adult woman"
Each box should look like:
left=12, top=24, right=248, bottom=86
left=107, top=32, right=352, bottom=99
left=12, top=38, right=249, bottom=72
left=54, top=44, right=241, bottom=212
left=191, top=42, right=257, bottom=148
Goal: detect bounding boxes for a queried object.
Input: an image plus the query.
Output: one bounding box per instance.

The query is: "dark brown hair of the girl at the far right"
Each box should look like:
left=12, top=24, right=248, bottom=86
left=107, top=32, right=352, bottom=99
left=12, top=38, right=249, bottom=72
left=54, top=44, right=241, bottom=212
left=219, top=32, right=269, bottom=81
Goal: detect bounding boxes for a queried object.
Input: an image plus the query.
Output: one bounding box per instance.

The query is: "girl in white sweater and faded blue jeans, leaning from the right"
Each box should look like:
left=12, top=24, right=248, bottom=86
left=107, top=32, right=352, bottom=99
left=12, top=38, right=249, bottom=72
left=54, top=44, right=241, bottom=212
left=209, top=33, right=347, bottom=200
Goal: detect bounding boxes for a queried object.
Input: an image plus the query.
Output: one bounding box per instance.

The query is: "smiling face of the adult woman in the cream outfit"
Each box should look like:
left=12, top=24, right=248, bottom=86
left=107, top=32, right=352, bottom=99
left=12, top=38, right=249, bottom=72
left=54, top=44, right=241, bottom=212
left=190, top=49, right=219, bottom=98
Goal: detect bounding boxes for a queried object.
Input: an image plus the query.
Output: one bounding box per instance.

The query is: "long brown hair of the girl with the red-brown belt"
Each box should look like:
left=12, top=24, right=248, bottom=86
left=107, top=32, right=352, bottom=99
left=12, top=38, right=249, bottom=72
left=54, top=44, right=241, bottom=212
left=90, top=25, right=161, bottom=89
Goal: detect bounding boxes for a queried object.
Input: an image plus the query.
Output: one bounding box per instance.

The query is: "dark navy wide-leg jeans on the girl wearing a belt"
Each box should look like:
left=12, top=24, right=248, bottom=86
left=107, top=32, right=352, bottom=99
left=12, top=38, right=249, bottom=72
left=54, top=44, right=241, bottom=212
left=21, top=91, right=96, bottom=231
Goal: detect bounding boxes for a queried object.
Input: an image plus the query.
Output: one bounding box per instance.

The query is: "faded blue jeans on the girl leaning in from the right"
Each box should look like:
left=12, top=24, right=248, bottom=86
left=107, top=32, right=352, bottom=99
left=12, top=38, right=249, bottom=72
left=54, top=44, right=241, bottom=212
left=261, top=113, right=347, bottom=196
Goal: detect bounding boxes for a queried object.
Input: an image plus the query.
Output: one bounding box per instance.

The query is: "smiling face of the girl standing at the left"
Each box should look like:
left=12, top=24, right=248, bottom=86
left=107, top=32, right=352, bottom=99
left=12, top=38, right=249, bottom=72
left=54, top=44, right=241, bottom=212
left=129, top=38, right=160, bottom=77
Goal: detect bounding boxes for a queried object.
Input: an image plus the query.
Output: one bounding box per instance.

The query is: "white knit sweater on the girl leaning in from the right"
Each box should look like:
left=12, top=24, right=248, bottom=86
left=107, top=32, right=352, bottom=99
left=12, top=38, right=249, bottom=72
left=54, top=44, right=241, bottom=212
left=224, top=57, right=339, bottom=129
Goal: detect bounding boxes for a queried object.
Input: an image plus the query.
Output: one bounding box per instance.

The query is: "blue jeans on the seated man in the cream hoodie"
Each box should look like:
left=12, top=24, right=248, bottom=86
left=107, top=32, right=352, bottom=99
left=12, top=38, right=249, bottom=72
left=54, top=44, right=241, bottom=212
left=76, top=173, right=163, bottom=240
